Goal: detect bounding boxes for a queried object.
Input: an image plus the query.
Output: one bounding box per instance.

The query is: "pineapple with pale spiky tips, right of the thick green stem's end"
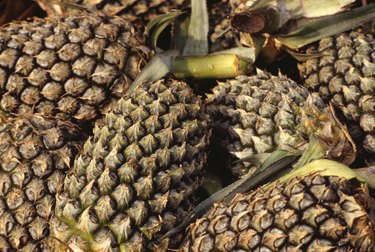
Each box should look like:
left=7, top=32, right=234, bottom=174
left=206, top=69, right=354, bottom=177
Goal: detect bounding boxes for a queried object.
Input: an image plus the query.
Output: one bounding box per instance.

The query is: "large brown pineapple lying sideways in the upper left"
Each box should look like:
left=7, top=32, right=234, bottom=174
left=0, top=14, right=149, bottom=123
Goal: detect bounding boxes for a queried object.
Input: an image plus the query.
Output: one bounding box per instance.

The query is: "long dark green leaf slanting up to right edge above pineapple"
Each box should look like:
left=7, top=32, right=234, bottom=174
left=275, top=4, right=375, bottom=49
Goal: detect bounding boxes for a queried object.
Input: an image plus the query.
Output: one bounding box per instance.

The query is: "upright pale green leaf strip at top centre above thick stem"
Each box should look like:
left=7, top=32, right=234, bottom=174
left=183, top=0, right=209, bottom=55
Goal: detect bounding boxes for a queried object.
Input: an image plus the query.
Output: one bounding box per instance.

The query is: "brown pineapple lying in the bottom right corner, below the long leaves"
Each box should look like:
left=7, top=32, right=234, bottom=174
left=180, top=160, right=375, bottom=252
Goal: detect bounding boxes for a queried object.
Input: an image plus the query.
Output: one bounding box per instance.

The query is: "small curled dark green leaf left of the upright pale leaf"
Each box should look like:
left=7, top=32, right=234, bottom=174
left=147, top=11, right=183, bottom=50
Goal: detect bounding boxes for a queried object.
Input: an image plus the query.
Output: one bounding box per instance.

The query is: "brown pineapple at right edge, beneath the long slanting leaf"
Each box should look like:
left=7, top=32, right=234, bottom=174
left=298, top=30, right=375, bottom=165
